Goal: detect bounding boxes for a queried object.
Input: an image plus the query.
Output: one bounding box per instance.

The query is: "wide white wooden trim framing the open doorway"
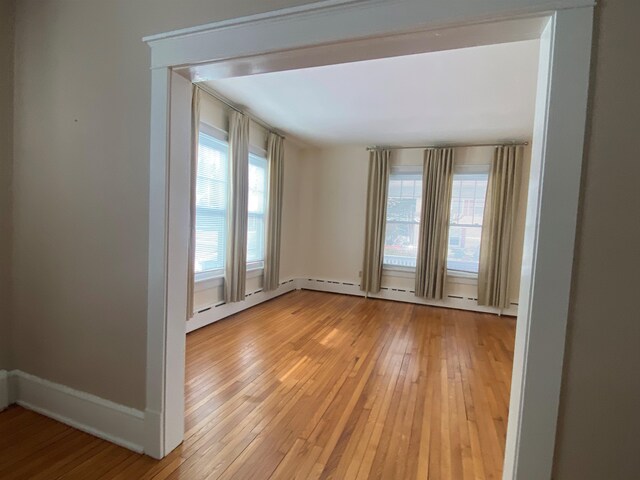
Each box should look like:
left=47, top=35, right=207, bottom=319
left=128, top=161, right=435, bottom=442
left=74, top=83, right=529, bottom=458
left=145, top=0, right=593, bottom=479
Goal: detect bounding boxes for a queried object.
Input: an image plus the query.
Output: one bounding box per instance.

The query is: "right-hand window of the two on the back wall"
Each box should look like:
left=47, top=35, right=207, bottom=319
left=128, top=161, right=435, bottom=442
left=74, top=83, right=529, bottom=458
left=447, top=172, right=489, bottom=274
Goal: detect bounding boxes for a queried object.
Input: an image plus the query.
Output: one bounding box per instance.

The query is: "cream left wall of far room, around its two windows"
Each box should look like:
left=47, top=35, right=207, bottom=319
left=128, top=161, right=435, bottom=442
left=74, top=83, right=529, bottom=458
left=194, top=92, right=300, bottom=311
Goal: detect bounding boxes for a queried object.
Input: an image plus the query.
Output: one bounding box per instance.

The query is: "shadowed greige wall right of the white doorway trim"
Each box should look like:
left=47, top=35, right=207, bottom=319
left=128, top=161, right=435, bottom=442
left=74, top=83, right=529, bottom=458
left=555, top=0, right=640, bottom=480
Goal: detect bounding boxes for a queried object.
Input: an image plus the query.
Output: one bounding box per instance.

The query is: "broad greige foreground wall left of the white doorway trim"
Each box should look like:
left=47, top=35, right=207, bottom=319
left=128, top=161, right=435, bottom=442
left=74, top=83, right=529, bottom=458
left=13, top=0, right=316, bottom=409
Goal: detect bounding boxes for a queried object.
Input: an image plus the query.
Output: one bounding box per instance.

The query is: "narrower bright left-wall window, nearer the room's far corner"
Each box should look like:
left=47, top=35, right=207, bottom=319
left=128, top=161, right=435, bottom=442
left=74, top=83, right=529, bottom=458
left=247, top=154, right=267, bottom=269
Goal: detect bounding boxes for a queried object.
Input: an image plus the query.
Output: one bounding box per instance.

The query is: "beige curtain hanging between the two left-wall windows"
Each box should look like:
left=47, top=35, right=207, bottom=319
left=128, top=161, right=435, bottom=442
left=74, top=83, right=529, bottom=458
left=224, top=111, right=249, bottom=303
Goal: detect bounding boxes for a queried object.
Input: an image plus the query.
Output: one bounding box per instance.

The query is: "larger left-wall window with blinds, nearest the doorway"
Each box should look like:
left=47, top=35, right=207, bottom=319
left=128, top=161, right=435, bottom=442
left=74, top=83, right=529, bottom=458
left=194, top=132, right=229, bottom=273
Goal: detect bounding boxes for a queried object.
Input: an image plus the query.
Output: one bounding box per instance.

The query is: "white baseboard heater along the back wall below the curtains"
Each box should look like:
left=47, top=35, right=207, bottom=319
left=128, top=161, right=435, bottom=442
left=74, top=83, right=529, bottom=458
left=297, top=278, right=518, bottom=317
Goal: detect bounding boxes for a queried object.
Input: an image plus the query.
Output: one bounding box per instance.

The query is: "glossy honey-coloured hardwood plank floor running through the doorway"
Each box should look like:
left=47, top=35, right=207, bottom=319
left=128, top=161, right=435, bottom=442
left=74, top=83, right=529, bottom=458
left=0, top=291, right=515, bottom=480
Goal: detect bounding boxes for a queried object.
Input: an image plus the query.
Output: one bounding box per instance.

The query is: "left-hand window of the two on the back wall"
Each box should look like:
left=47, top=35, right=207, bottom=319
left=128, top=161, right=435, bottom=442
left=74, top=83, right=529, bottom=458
left=383, top=171, right=422, bottom=269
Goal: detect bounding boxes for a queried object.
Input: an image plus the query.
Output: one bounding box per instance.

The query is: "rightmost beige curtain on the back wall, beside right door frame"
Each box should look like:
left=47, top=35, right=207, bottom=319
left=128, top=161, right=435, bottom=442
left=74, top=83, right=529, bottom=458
left=478, top=146, right=522, bottom=308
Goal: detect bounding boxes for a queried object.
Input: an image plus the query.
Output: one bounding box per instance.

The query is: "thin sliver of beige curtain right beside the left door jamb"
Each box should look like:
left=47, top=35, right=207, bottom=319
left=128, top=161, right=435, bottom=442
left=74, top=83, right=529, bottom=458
left=187, top=85, right=200, bottom=318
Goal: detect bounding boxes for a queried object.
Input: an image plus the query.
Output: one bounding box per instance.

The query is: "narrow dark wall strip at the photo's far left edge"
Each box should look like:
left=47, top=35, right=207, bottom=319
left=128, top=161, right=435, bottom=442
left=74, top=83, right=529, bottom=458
left=0, top=0, right=15, bottom=370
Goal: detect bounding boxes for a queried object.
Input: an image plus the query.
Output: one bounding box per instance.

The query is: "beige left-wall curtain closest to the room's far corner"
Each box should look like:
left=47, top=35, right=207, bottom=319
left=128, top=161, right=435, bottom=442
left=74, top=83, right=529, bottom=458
left=263, top=133, right=284, bottom=292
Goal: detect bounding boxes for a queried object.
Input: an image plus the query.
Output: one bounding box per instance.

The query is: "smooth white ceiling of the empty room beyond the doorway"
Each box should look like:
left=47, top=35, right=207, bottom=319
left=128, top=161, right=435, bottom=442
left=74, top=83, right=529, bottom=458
left=206, top=40, right=539, bottom=145
